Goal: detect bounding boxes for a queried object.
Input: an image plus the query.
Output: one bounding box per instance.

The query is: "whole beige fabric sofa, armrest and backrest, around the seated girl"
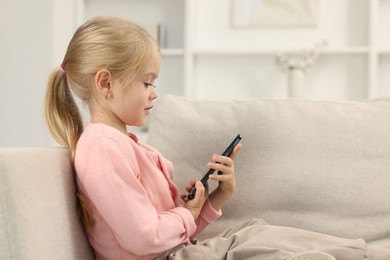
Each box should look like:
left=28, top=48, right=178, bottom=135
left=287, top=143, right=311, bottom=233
left=0, top=96, right=390, bottom=260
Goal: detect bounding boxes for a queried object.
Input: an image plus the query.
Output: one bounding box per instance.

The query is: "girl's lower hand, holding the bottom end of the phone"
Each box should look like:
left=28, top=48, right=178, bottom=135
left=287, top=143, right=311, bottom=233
left=181, top=181, right=209, bottom=220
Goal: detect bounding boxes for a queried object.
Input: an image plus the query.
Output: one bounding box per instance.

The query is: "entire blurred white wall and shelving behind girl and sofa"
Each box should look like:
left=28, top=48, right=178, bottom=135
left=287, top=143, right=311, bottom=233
left=0, top=0, right=390, bottom=147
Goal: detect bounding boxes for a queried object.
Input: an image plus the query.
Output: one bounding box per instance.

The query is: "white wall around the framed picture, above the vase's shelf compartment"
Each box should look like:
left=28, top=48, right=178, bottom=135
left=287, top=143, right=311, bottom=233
left=194, top=0, right=369, bottom=50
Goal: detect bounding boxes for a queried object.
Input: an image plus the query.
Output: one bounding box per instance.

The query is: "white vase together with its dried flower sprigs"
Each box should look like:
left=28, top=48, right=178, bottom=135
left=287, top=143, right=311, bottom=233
left=275, top=40, right=328, bottom=98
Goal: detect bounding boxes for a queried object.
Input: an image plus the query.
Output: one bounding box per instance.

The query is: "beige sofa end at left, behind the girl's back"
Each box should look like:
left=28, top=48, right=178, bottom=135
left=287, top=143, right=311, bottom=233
left=0, top=148, right=94, bottom=260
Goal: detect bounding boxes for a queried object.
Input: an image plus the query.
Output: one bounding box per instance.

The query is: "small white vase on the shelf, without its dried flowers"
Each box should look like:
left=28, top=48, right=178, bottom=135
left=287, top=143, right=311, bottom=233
left=288, top=68, right=307, bottom=98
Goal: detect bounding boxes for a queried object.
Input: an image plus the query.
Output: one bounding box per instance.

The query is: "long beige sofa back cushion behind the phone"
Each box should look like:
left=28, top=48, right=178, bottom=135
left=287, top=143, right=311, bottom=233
left=148, top=96, right=390, bottom=247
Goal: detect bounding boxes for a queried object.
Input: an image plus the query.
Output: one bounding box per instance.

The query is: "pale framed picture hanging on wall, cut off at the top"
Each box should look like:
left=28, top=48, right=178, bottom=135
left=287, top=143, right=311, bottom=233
left=231, top=0, right=320, bottom=28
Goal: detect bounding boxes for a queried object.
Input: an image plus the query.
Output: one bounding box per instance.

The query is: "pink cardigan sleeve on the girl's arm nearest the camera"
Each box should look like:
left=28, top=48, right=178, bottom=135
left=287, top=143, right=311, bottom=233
left=82, top=138, right=196, bottom=255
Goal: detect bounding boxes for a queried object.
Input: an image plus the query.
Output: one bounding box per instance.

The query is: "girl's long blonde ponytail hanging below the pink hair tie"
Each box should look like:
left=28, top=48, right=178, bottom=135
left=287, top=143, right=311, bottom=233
left=45, top=69, right=83, bottom=160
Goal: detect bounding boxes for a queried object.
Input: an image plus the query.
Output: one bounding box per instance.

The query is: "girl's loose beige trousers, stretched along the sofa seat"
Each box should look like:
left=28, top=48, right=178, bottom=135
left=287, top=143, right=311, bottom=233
left=157, top=219, right=390, bottom=260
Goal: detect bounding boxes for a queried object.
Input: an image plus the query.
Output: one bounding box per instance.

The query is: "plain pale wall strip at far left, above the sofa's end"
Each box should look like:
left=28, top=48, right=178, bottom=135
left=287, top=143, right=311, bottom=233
left=0, top=0, right=53, bottom=147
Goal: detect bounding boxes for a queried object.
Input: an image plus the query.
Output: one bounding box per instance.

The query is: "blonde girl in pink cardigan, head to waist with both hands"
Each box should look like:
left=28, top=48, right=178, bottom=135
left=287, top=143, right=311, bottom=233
left=45, top=17, right=240, bottom=259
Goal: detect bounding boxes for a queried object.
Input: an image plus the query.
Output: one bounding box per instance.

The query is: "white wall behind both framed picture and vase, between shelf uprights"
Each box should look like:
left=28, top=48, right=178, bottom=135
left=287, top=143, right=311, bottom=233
left=192, top=0, right=371, bottom=100
